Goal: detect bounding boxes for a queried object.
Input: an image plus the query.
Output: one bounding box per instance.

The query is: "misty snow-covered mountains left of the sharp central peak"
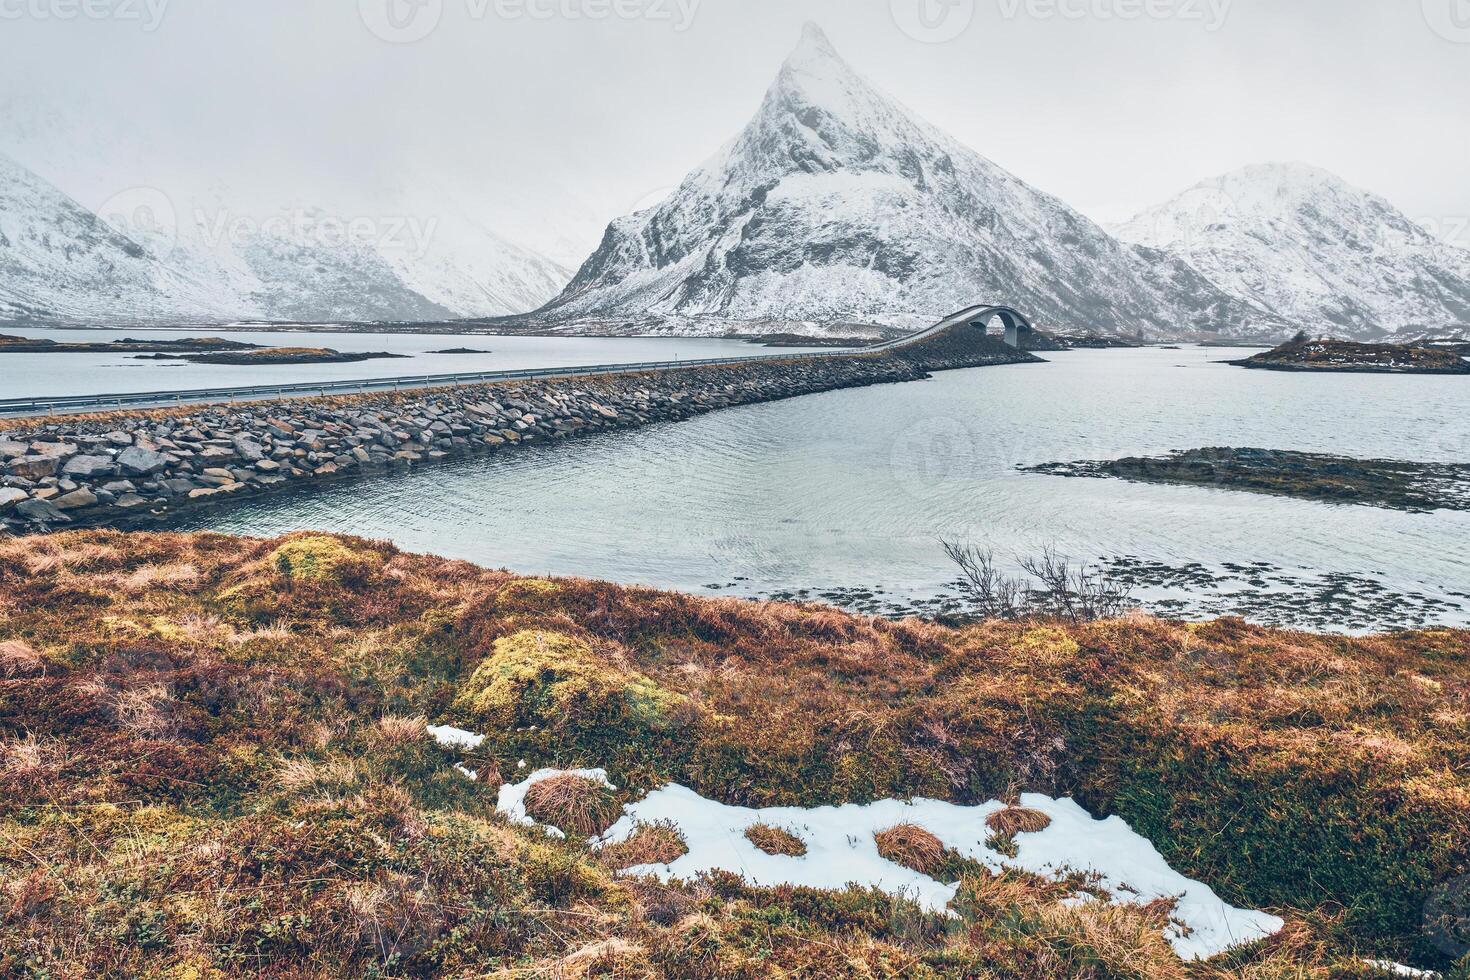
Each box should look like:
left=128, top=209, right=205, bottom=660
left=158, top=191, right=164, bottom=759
left=0, top=154, right=570, bottom=323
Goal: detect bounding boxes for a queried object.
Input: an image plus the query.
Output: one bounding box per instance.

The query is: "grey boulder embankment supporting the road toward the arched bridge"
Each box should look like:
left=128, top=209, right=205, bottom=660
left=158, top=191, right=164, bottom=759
left=0, top=342, right=1036, bottom=532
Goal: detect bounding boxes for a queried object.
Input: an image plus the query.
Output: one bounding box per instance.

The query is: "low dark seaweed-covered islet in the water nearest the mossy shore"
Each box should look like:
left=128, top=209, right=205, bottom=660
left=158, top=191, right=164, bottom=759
left=1022, top=448, right=1470, bottom=513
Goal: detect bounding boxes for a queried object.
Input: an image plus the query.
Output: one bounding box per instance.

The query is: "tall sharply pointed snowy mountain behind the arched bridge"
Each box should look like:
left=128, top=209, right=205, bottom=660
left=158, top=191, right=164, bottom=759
left=541, top=25, right=1279, bottom=334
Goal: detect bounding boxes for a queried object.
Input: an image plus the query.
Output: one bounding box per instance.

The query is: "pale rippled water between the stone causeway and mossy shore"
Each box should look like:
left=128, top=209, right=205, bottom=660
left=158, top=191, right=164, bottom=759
left=166, top=348, right=1470, bottom=630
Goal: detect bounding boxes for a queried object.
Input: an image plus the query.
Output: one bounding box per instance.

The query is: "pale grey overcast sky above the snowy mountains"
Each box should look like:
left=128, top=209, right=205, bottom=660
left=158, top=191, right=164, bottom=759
left=0, top=0, right=1470, bottom=264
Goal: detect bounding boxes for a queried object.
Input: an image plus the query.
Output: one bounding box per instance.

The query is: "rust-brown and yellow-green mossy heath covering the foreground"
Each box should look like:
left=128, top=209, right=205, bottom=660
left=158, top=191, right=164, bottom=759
left=0, top=532, right=1470, bottom=979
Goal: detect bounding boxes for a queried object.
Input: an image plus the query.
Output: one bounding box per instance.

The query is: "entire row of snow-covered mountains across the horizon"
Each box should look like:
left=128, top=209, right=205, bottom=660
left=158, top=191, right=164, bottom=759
left=0, top=25, right=1470, bottom=338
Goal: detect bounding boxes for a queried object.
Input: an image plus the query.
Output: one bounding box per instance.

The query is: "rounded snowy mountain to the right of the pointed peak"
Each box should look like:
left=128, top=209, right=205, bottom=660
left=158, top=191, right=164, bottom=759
left=1114, top=165, right=1470, bottom=338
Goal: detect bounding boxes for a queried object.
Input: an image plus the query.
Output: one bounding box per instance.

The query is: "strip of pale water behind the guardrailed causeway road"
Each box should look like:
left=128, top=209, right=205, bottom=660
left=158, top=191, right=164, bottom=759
left=0, top=328, right=829, bottom=398
